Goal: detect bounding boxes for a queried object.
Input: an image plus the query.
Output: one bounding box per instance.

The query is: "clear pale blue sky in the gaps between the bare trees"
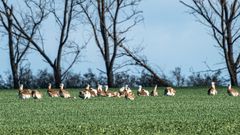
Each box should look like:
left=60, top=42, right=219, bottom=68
left=0, top=0, right=223, bottom=78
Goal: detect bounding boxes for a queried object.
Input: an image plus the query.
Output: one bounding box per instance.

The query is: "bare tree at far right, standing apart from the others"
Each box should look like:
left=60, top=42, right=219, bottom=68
left=180, top=0, right=240, bottom=85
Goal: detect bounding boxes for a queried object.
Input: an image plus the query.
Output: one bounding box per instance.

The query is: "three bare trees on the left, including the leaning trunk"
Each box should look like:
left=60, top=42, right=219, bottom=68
left=0, top=0, right=168, bottom=88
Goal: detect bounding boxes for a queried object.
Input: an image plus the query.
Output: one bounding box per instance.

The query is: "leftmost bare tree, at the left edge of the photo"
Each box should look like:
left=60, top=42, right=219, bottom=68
left=0, top=0, right=39, bottom=89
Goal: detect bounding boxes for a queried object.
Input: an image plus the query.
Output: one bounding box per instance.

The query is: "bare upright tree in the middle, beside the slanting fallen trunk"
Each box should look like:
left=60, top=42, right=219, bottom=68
left=78, top=0, right=143, bottom=86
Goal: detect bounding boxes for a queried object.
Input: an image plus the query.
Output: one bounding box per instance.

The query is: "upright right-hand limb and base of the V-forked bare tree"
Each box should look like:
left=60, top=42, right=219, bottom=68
left=47, top=0, right=85, bottom=85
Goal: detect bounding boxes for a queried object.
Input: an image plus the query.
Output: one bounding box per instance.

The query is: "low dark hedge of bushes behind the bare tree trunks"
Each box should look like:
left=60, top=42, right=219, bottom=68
left=0, top=66, right=225, bottom=89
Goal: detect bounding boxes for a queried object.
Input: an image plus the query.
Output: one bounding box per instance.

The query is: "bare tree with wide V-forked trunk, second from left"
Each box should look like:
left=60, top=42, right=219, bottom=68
left=1, top=0, right=83, bottom=86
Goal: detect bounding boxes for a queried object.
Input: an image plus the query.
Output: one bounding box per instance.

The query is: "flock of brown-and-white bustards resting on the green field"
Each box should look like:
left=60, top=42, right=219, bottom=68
left=18, top=82, right=239, bottom=100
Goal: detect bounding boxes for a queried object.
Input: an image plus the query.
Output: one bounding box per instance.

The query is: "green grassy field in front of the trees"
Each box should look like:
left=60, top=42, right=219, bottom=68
left=0, top=88, right=240, bottom=135
